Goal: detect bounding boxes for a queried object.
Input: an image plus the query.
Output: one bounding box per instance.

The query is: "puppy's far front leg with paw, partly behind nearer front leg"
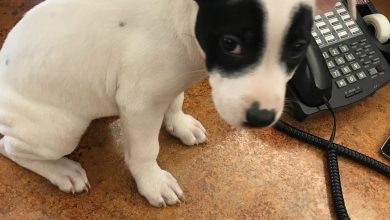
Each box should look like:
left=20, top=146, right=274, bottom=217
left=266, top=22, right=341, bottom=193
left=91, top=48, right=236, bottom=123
left=164, top=93, right=207, bottom=145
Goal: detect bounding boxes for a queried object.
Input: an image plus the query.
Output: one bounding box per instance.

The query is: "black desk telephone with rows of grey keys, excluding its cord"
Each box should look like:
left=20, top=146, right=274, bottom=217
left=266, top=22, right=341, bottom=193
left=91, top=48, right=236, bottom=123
left=287, top=1, right=390, bottom=120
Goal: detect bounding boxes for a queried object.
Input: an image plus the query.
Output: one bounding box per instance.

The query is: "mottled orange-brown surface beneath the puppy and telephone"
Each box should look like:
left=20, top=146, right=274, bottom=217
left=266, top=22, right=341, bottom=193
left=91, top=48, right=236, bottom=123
left=0, top=0, right=390, bottom=219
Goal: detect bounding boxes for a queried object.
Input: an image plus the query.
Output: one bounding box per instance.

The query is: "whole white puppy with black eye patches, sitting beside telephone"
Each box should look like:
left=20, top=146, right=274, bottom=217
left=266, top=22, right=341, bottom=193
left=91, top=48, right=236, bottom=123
left=0, top=0, right=354, bottom=207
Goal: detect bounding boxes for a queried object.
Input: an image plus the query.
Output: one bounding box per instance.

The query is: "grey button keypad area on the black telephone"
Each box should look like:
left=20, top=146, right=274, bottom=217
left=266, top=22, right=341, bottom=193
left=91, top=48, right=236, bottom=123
left=312, top=3, right=386, bottom=98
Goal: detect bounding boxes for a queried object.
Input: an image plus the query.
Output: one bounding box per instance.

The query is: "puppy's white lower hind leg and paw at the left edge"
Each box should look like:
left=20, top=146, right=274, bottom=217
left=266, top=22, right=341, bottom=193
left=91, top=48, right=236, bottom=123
left=0, top=136, right=90, bottom=193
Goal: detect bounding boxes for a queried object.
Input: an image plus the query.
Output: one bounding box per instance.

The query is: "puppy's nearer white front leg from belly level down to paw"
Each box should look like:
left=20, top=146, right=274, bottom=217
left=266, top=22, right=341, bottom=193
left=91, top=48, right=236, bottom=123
left=119, top=99, right=183, bottom=207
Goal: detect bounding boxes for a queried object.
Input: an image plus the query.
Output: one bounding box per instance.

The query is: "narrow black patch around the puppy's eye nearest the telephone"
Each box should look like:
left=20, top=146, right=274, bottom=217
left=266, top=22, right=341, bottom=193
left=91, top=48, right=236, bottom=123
left=281, top=5, right=313, bottom=73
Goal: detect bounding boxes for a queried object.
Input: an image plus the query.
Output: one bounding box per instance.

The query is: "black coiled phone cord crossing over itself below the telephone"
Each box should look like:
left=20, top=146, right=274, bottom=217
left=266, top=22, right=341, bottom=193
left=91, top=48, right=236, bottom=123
left=274, top=98, right=390, bottom=220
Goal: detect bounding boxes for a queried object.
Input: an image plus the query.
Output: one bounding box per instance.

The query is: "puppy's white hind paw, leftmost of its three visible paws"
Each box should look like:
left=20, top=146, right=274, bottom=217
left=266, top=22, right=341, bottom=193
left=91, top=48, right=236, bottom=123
left=46, top=158, right=91, bottom=194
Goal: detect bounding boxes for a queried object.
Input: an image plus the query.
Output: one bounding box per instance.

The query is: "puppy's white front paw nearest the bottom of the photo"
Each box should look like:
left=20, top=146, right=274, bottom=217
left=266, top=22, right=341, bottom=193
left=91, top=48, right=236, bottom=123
left=135, top=169, right=184, bottom=208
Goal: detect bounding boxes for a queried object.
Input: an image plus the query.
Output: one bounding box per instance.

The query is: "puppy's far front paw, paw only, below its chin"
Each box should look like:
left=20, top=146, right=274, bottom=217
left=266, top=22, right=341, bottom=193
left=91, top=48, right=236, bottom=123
left=165, top=113, right=207, bottom=146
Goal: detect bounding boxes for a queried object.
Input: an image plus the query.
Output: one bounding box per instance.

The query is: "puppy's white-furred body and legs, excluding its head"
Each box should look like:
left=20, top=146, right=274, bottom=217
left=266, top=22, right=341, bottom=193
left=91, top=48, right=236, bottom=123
left=0, top=0, right=206, bottom=206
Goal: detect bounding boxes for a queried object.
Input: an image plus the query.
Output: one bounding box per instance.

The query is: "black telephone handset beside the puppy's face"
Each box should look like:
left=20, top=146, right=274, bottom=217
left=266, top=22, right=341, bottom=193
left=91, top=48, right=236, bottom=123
left=290, top=39, right=332, bottom=107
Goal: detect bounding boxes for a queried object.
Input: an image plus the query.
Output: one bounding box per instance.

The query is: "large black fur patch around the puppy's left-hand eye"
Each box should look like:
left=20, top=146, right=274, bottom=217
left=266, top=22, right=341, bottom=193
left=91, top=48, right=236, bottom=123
left=195, top=0, right=265, bottom=76
